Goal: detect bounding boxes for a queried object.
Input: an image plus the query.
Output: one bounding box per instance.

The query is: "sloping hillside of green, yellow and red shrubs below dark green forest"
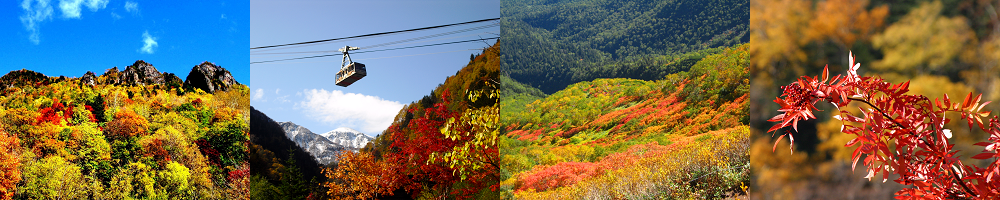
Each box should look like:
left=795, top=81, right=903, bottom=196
left=500, top=44, right=750, bottom=199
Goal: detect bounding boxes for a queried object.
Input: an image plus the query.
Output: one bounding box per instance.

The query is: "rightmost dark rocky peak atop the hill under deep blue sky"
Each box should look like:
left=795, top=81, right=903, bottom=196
left=184, top=61, right=239, bottom=93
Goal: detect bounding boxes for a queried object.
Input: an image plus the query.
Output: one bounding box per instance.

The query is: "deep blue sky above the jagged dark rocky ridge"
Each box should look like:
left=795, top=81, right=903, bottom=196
left=0, top=0, right=250, bottom=83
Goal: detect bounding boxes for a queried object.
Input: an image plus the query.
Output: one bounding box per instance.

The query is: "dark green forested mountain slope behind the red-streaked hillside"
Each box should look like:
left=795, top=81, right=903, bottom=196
left=497, top=0, right=750, bottom=94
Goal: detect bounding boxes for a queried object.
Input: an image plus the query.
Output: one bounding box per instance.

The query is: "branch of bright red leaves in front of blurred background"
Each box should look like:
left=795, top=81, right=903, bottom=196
left=768, top=52, right=1000, bottom=199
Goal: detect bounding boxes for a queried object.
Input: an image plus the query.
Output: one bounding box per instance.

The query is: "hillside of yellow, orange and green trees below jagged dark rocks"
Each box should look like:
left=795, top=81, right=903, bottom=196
left=0, top=61, right=249, bottom=199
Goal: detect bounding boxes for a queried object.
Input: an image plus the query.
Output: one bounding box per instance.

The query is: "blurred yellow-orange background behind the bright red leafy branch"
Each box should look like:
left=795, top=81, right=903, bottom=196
left=749, top=0, right=1000, bottom=199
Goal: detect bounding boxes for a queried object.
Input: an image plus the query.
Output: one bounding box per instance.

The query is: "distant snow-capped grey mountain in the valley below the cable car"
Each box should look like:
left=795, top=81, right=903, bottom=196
left=278, top=122, right=348, bottom=164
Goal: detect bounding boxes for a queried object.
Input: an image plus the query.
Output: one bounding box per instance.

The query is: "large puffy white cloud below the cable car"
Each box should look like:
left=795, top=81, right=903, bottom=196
left=297, top=89, right=403, bottom=134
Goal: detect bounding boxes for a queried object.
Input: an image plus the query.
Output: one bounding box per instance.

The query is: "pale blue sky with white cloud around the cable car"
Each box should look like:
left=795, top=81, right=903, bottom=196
left=250, top=0, right=500, bottom=136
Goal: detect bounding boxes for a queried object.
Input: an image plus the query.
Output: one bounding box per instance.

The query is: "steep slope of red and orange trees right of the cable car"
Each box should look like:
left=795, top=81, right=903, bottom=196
left=323, top=48, right=500, bottom=199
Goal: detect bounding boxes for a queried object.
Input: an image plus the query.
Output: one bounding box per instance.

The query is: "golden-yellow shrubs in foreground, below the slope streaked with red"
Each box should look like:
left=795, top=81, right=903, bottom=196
left=502, top=126, right=750, bottom=199
